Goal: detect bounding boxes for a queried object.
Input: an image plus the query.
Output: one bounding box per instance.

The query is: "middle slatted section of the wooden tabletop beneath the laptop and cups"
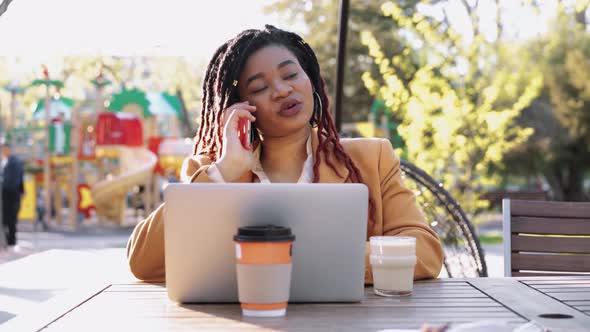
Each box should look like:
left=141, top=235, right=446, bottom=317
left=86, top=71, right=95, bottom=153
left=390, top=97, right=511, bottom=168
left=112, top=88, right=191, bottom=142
left=24, top=281, right=526, bottom=331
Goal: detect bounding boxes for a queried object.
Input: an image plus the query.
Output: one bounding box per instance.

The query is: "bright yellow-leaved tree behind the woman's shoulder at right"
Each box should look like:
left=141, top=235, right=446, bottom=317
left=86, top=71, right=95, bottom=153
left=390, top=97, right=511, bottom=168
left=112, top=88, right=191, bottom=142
left=362, top=0, right=542, bottom=214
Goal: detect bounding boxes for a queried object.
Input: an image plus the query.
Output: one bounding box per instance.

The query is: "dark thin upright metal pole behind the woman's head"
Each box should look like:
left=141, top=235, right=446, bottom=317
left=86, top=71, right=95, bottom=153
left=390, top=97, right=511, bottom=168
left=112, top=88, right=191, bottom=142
left=334, top=0, right=350, bottom=132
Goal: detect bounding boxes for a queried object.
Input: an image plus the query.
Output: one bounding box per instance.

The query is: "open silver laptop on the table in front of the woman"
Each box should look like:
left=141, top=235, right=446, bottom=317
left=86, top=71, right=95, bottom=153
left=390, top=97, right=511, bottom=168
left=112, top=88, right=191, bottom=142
left=164, top=183, right=368, bottom=303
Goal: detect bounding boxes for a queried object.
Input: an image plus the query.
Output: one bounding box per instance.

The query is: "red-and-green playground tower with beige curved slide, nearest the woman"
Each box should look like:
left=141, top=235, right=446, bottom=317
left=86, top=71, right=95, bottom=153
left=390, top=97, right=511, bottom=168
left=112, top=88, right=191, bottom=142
left=92, top=89, right=192, bottom=223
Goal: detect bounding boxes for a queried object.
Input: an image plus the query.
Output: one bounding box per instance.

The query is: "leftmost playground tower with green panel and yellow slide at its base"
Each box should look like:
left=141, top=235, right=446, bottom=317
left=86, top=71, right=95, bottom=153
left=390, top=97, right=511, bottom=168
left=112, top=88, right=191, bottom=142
left=7, top=83, right=77, bottom=227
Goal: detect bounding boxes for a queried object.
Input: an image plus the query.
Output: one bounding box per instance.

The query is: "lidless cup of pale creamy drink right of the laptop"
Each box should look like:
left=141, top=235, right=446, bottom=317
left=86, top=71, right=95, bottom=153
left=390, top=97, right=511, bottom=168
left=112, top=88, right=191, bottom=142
left=369, top=236, right=416, bottom=296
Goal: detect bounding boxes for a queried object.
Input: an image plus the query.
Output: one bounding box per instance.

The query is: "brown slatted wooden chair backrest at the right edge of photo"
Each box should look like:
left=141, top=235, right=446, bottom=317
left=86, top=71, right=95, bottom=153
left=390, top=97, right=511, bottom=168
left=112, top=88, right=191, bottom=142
left=502, top=199, right=590, bottom=277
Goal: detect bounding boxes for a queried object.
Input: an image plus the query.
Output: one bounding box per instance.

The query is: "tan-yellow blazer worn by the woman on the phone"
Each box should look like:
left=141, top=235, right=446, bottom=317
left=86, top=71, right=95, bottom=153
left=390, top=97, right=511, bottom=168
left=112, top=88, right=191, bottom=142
left=127, top=131, right=443, bottom=283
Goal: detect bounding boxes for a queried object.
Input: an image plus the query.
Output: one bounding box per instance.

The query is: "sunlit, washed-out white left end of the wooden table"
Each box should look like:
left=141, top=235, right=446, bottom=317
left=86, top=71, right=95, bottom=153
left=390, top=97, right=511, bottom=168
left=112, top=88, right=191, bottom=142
left=0, top=248, right=135, bottom=332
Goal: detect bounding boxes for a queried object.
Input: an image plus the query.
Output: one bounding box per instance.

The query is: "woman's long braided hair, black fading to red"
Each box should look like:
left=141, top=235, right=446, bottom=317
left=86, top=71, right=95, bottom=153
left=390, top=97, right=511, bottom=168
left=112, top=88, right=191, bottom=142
left=193, top=25, right=375, bottom=224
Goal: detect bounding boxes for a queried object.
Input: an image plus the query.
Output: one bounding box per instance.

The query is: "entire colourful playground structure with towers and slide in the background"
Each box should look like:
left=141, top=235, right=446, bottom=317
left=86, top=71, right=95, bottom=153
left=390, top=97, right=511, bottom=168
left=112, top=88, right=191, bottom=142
left=11, top=67, right=192, bottom=227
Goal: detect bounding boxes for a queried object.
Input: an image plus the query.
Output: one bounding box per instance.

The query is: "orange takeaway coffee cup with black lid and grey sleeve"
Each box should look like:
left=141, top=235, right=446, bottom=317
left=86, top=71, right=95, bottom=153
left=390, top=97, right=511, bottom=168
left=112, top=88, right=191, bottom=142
left=234, top=225, right=295, bottom=317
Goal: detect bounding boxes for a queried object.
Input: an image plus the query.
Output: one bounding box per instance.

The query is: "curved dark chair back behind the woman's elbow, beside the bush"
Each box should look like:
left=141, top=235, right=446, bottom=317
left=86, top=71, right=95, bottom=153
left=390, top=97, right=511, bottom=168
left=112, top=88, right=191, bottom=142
left=400, top=160, right=488, bottom=278
